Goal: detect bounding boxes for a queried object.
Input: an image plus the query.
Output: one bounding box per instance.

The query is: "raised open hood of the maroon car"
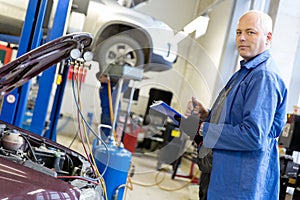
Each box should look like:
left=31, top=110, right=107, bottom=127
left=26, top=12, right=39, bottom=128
left=0, top=33, right=93, bottom=96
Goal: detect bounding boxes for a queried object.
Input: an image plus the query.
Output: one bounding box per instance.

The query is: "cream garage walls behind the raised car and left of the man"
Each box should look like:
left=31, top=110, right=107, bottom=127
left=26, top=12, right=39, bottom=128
left=132, top=0, right=232, bottom=111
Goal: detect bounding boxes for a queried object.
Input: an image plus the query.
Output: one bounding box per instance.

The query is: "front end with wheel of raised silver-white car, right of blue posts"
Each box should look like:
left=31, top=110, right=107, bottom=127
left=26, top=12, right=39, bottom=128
left=76, top=0, right=177, bottom=72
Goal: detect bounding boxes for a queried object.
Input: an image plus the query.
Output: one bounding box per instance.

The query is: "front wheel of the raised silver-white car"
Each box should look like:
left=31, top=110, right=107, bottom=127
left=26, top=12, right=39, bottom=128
left=94, top=34, right=145, bottom=72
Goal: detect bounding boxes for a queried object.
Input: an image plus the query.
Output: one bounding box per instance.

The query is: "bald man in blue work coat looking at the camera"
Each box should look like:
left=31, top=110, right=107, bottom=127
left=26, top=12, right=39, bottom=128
left=186, top=10, right=287, bottom=200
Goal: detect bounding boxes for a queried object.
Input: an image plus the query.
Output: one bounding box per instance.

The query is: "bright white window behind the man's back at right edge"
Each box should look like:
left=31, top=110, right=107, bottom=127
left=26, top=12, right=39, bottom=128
left=272, top=0, right=300, bottom=114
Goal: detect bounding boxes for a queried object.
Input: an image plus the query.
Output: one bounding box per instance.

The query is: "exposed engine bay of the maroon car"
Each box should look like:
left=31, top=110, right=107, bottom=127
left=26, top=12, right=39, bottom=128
left=0, top=124, right=103, bottom=199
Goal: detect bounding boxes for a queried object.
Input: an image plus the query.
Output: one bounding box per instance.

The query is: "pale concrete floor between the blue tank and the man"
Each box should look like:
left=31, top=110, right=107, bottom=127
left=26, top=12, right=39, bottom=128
left=125, top=153, right=198, bottom=200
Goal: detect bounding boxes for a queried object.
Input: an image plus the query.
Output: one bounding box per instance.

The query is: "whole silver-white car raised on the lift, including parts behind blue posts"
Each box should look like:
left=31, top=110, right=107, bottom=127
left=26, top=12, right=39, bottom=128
left=0, top=0, right=177, bottom=72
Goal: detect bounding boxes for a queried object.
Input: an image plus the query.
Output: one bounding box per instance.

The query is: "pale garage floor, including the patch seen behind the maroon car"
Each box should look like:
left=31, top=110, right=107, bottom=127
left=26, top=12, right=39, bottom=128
left=57, top=135, right=199, bottom=200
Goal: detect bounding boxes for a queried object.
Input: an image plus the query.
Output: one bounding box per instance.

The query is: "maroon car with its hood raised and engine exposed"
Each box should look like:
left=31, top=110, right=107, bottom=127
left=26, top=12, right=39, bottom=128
left=0, top=33, right=103, bottom=200
